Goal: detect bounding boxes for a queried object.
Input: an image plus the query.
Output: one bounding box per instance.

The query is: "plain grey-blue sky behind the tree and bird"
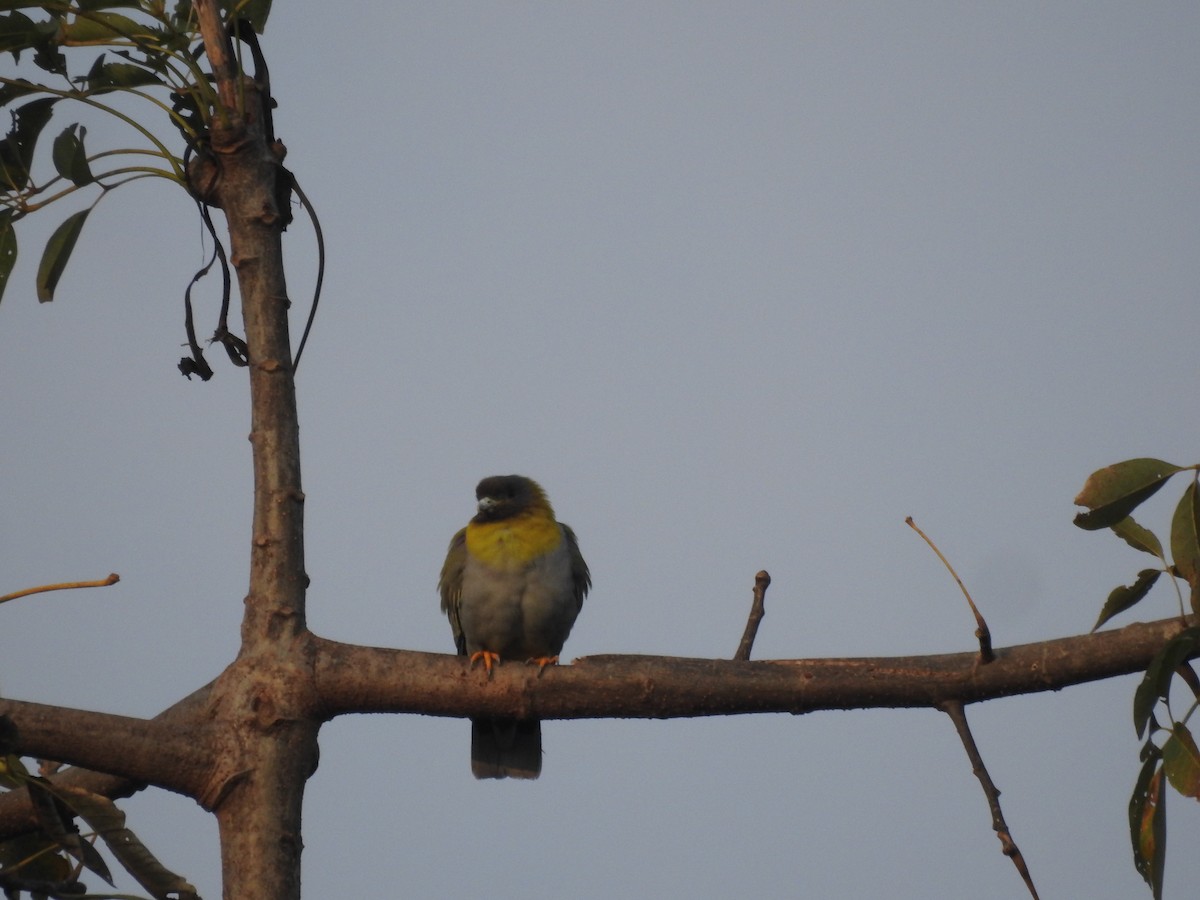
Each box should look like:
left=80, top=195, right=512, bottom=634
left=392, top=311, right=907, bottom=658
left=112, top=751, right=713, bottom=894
left=0, top=1, right=1200, bottom=900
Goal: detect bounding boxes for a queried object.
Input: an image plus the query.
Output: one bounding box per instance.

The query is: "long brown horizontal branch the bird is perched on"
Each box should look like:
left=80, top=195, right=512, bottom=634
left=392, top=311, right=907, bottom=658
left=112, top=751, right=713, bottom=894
left=311, top=619, right=1183, bottom=719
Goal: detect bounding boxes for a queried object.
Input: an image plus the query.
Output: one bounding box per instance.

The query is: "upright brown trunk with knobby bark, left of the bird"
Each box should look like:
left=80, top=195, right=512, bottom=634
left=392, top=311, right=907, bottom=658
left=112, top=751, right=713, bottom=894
left=194, top=0, right=319, bottom=900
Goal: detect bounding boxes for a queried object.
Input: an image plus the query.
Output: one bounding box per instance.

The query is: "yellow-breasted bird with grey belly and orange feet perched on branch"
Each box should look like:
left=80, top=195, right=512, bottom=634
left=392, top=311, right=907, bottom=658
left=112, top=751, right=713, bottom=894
left=438, top=475, right=592, bottom=779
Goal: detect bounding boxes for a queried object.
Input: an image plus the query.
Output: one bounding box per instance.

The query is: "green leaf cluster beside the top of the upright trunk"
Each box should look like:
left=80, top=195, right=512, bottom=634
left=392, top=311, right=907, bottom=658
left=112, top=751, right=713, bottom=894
left=0, top=0, right=270, bottom=302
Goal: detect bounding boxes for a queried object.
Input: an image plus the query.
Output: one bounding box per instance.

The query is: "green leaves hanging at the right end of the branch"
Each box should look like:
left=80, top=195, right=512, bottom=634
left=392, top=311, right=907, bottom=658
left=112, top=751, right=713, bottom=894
left=1075, top=458, right=1200, bottom=900
